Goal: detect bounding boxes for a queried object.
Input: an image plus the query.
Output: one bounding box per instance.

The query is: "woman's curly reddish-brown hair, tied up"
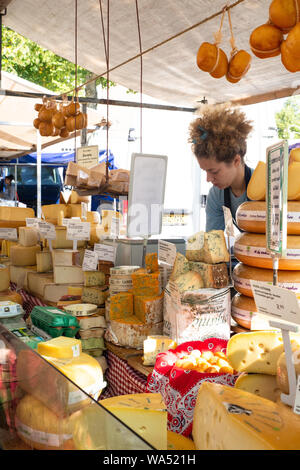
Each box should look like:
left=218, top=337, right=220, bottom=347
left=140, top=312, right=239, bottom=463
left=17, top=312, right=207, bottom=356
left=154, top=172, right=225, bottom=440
left=189, top=104, right=252, bottom=163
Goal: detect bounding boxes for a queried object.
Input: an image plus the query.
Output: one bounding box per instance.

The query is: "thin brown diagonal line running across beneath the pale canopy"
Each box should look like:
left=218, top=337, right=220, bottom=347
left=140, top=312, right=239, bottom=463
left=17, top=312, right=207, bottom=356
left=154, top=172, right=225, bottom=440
left=53, top=0, right=246, bottom=99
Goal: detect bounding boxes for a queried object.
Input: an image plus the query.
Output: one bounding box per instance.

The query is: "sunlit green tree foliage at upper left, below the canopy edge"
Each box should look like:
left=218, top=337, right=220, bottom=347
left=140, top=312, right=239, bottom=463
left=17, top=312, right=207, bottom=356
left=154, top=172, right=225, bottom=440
left=2, top=27, right=115, bottom=95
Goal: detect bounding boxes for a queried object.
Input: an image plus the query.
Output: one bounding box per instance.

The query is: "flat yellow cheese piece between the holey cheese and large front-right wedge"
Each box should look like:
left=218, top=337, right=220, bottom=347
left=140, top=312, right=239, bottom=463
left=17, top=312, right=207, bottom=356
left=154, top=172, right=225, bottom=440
left=234, top=373, right=280, bottom=402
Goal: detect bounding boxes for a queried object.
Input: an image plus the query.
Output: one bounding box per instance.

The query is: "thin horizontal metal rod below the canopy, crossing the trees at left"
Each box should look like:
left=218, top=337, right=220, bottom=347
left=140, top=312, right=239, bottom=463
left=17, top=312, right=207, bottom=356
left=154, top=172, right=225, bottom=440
left=0, top=86, right=196, bottom=113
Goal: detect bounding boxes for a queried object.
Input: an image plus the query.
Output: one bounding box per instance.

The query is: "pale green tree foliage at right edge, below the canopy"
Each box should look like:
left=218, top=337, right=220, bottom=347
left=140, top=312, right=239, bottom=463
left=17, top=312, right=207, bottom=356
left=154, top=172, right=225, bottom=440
left=275, top=96, right=300, bottom=139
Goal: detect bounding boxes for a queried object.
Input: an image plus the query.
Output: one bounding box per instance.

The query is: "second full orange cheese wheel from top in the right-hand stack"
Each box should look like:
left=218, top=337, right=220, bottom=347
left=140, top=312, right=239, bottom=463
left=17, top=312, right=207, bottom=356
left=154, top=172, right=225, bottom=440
left=233, top=232, right=300, bottom=271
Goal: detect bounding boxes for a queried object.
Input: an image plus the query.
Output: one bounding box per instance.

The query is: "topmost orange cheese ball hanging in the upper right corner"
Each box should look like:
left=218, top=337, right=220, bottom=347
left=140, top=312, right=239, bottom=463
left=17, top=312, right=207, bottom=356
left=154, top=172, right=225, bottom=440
left=269, top=0, right=300, bottom=33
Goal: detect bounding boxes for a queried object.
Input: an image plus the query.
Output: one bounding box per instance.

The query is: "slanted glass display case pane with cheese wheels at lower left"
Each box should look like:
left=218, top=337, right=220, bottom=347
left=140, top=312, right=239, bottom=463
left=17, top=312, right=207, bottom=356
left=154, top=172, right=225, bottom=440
left=0, top=323, right=153, bottom=450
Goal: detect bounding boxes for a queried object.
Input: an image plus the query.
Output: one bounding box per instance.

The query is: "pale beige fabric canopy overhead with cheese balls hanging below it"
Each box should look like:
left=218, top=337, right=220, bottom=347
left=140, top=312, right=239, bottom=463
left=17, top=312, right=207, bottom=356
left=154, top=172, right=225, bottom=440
left=3, top=0, right=300, bottom=107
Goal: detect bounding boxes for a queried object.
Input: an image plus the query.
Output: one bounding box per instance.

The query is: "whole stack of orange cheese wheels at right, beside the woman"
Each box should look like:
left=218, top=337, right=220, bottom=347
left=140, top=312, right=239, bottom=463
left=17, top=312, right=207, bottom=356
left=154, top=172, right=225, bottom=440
left=231, top=157, right=300, bottom=329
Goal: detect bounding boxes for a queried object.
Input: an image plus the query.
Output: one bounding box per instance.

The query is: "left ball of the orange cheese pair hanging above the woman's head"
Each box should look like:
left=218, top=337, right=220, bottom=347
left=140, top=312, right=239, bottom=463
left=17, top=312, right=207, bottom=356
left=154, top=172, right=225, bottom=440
left=197, top=42, right=227, bottom=78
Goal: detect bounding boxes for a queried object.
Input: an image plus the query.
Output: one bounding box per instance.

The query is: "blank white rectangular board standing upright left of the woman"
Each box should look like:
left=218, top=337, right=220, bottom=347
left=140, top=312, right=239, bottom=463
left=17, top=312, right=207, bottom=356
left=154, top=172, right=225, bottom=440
left=127, top=153, right=168, bottom=238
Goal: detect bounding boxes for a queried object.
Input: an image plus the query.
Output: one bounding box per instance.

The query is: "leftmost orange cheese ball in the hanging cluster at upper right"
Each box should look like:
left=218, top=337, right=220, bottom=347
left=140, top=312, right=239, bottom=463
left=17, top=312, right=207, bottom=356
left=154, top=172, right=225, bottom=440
left=249, top=24, right=283, bottom=59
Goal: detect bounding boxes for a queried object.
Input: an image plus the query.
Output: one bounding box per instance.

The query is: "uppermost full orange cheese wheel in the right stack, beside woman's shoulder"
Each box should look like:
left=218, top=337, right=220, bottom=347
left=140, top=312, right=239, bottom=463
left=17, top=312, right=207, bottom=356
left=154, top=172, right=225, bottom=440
left=236, top=201, right=300, bottom=235
